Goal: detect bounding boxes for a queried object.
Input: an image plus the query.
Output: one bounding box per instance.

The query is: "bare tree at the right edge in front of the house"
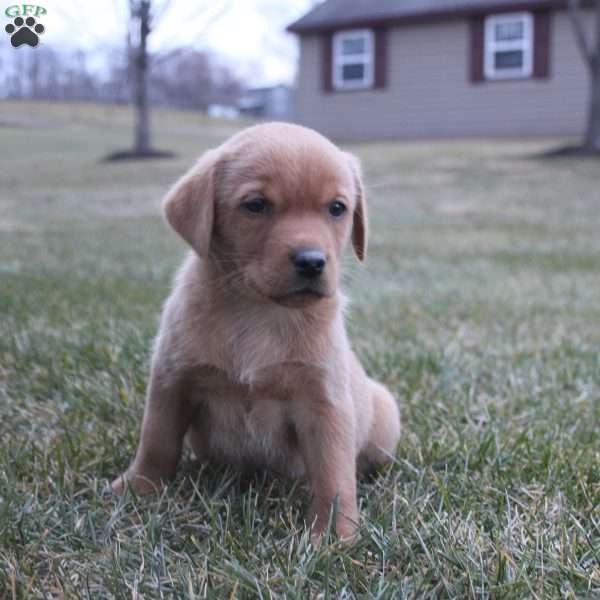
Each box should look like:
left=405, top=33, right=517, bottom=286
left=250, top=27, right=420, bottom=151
left=569, top=0, right=600, bottom=153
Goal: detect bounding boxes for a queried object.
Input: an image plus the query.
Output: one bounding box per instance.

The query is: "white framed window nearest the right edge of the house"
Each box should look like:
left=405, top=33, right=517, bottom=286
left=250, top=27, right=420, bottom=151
left=484, top=13, right=533, bottom=79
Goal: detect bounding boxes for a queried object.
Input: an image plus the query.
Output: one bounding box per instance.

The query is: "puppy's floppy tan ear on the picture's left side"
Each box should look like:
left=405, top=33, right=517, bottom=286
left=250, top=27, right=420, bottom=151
left=163, top=150, right=220, bottom=258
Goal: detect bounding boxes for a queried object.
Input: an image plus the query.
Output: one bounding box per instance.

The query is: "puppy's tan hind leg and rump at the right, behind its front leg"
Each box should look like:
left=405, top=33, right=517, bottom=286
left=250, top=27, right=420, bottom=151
left=358, top=379, right=400, bottom=472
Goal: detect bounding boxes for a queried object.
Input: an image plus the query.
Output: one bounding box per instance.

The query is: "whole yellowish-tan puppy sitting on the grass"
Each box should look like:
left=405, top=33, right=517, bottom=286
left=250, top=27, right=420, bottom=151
left=112, top=123, right=400, bottom=539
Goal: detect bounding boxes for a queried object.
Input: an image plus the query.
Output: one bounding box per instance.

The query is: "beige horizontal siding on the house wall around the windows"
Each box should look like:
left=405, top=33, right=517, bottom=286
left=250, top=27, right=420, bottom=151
left=295, top=12, right=592, bottom=140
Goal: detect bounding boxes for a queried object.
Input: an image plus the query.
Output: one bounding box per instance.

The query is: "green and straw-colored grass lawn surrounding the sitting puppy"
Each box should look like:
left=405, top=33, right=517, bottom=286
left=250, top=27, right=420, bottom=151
left=0, top=103, right=600, bottom=599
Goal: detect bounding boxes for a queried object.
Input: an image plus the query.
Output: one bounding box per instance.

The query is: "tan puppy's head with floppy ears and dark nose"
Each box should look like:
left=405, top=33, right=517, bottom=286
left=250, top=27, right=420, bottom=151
left=164, top=123, right=367, bottom=306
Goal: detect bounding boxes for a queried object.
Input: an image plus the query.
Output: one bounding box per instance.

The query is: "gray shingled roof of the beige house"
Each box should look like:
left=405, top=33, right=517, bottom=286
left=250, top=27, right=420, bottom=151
left=288, top=0, right=564, bottom=33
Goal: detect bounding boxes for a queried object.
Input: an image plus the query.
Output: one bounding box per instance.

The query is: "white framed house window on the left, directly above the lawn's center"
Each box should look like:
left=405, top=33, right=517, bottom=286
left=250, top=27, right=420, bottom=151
left=332, top=29, right=375, bottom=90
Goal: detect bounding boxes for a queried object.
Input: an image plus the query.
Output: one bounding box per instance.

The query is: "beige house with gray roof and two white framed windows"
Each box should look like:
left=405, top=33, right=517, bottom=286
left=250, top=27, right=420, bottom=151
left=288, top=0, right=595, bottom=140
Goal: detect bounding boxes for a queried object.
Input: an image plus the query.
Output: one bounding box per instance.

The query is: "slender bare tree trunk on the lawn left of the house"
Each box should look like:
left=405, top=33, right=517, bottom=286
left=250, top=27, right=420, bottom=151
left=133, top=0, right=151, bottom=154
